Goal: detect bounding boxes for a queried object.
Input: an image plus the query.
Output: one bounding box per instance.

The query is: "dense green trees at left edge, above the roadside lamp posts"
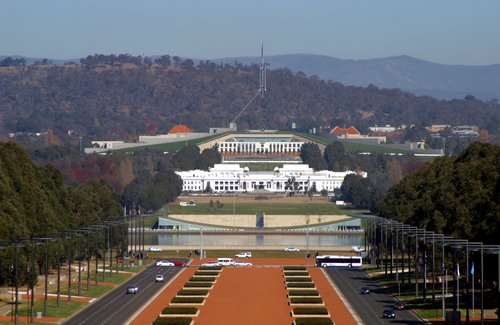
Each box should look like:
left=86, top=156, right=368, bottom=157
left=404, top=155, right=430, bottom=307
left=0, top=142, right=122, bottom=240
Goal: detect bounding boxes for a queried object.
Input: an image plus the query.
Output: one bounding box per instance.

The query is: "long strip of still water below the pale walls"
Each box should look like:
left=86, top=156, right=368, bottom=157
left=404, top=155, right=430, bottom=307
left=144, top=233, right=364, bottom=247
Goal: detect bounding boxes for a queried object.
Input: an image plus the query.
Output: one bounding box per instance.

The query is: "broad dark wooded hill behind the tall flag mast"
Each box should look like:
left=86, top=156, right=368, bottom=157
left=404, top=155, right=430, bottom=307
left=0, top=56, right=500, bottom=140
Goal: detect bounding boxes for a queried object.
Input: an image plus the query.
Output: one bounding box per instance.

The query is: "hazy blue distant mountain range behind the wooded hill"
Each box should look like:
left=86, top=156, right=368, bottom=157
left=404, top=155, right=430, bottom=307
left=0, top=54, right=500, bottom=101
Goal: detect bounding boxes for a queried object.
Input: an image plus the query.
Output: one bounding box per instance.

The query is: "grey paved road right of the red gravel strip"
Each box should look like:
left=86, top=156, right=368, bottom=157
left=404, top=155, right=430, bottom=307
left=325, top=268, right=425, bottom=325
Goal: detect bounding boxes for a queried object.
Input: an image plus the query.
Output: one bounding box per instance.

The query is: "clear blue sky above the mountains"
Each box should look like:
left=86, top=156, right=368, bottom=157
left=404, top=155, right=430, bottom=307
left=0, top=0, right=500, bottom=65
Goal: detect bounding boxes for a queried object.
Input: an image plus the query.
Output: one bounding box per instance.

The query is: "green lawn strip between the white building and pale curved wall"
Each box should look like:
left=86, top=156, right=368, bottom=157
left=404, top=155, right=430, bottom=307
left=164, top=200, right=349, bottom=215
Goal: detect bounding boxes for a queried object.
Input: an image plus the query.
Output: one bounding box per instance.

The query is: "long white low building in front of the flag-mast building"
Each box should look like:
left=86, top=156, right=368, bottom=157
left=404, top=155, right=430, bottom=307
left=176, top=164, right=367, bottom=193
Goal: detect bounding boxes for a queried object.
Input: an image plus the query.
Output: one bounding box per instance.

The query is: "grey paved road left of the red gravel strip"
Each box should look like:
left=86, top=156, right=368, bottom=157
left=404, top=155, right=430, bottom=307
left=64, top=260, right=187, bottom=325
